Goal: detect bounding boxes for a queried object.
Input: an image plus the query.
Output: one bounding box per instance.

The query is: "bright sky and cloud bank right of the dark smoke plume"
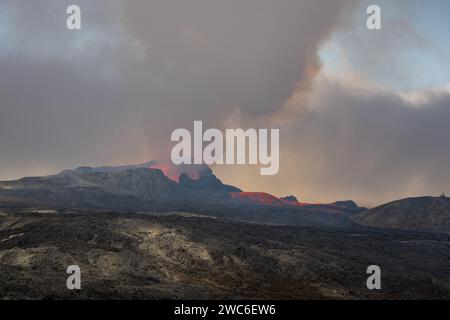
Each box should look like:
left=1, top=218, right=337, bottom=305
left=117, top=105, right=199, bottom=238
left=219, top=2, right=450, bottom=206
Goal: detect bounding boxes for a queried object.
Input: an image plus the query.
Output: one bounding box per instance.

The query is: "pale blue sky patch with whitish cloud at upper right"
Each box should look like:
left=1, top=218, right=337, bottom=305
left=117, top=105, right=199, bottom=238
left=320, top=0, right=450, bottom=90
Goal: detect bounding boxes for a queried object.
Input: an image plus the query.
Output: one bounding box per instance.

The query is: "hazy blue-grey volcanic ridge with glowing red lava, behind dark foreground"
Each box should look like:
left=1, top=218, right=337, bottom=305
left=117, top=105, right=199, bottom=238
left=0, top=161, right=364, bottom=225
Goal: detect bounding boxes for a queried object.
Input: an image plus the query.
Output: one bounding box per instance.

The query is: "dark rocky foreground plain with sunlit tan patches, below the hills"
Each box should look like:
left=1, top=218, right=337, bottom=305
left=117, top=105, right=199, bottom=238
left=0, top=212, right=450, bottom=299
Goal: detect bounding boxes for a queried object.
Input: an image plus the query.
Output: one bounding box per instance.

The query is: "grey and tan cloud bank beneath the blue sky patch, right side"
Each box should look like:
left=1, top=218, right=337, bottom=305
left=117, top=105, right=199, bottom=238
left=227, top=74, right=450, bottom=206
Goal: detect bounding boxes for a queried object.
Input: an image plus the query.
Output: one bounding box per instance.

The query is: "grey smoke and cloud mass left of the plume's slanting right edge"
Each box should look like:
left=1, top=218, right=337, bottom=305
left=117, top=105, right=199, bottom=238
left=0, top=0, right=352, bottom=179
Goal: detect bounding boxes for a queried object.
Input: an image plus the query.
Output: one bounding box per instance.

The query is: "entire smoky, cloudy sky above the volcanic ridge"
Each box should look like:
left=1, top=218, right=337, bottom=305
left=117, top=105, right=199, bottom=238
left=0, top=0, right=450, bottom=206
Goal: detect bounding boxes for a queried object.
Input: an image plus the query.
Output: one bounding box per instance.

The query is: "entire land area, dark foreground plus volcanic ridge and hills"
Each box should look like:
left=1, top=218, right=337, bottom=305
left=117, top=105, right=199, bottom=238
left=0, top=162, right=450, bottom=299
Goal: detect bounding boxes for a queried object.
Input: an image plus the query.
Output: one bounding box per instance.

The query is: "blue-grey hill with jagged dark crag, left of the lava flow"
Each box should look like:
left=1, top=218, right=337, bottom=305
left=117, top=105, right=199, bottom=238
left=0, top=166, right=240, bottom=212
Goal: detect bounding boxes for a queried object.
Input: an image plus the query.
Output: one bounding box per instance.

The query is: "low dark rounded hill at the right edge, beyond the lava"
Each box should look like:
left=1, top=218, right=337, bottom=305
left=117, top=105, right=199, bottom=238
left=352, top=197, right=450, bottom=233
